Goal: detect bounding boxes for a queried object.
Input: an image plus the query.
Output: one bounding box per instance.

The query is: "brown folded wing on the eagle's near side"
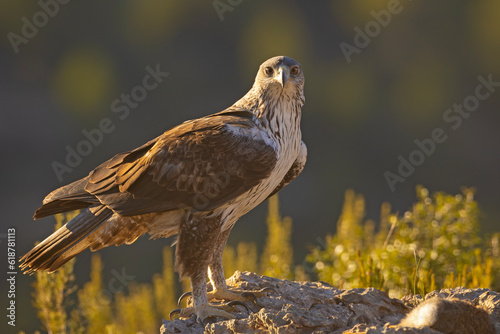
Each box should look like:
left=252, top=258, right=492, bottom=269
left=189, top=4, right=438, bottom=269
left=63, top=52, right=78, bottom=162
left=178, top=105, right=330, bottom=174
left=35, top=110, right=277, bottom=218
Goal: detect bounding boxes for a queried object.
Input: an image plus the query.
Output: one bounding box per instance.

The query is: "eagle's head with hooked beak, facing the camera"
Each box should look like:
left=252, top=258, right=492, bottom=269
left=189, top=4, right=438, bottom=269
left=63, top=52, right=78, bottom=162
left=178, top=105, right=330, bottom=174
left=254, top=56, right=304, bottom=98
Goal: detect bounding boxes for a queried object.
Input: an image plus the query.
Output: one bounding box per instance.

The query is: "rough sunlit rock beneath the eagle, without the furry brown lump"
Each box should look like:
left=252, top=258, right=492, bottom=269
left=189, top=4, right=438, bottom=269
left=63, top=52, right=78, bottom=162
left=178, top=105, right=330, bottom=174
left=161, top=271, right=500, bottom=334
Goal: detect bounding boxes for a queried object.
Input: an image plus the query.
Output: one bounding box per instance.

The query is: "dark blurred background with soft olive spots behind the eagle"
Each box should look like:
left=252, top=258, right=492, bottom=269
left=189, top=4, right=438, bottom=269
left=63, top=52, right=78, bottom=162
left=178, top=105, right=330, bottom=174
left=0, top=0, right=500, bottom=332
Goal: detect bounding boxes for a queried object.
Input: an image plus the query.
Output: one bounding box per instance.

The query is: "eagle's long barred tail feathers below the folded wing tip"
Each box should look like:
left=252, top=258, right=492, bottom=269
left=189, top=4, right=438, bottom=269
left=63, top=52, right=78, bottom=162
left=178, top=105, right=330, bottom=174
left=20, top=205, right=113, bottom=274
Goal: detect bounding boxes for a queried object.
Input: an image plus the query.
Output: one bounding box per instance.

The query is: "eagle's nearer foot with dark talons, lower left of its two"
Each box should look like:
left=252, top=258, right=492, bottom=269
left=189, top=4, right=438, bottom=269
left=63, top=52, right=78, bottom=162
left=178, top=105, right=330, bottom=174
left=169, top=301, right=250, bottom=326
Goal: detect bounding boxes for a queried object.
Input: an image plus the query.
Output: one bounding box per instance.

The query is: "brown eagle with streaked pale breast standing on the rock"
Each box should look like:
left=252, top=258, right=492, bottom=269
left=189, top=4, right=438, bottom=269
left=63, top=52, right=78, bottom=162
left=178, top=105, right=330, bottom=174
left=20, top=56, right=307, bottom=323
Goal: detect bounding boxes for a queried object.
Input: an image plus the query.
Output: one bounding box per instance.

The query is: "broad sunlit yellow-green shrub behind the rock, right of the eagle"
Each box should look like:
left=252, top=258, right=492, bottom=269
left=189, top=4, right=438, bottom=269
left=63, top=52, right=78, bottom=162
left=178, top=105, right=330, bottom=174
left=307, top=186, right=499, bottom=297
